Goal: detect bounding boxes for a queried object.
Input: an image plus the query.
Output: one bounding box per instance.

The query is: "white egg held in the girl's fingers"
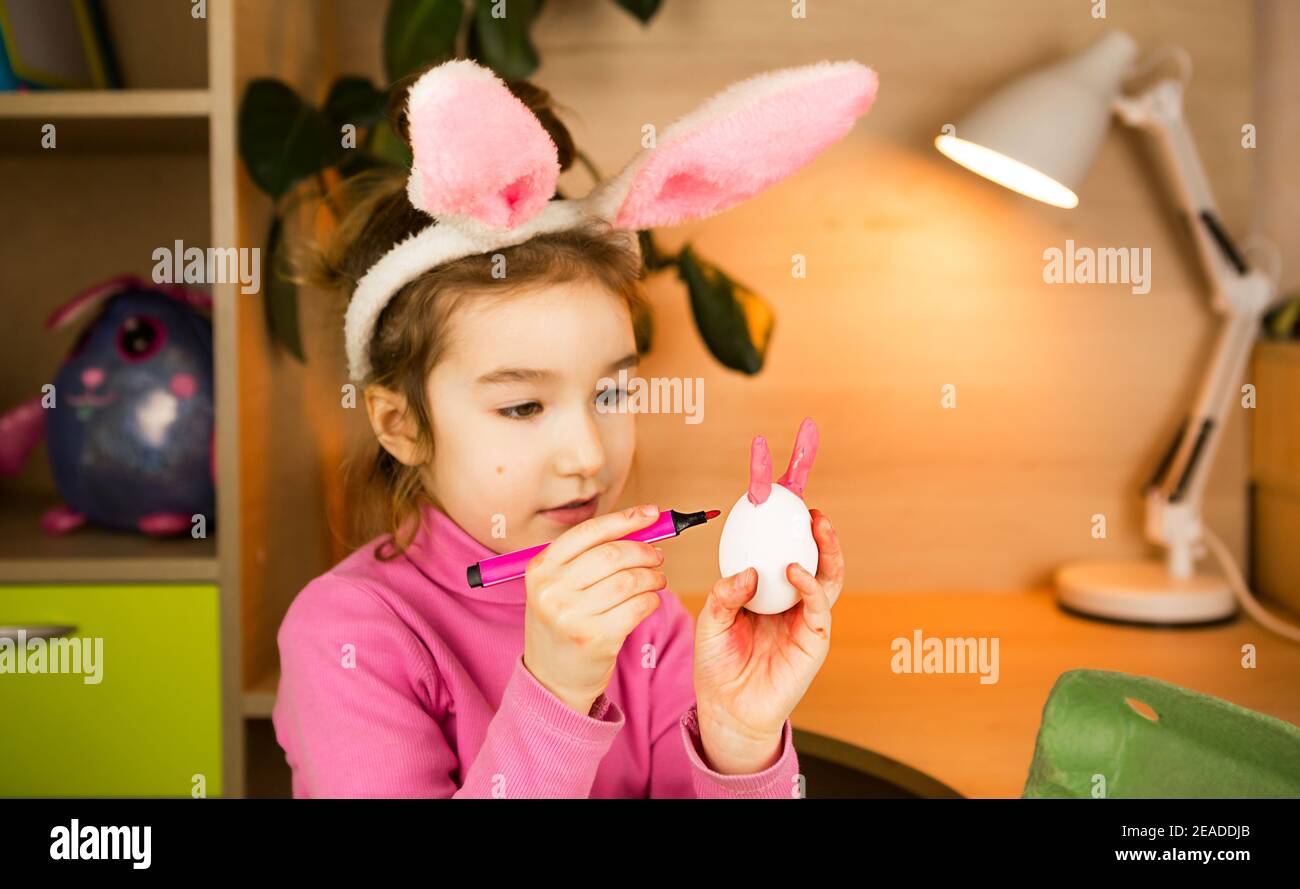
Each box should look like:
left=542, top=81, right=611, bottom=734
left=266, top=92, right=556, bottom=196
left=718, top=485, right=818, bottom=615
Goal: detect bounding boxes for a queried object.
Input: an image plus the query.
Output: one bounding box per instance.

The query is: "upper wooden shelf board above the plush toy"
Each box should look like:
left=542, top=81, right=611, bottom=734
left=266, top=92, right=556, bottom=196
left=0, top=90, right=212, bottom=121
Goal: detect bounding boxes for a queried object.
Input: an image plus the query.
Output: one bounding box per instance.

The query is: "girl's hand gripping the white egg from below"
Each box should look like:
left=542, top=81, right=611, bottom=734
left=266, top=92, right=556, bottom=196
left=696, top=509, right=844, bottom=775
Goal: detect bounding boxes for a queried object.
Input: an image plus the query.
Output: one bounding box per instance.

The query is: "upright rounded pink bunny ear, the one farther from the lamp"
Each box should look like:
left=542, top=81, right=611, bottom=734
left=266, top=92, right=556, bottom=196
left=407, top=58, right=560, bottom=229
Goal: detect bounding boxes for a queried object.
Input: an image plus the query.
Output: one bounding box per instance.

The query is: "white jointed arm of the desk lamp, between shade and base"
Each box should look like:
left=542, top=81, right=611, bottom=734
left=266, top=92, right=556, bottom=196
left=1115, top=81, right=1277, bottom=577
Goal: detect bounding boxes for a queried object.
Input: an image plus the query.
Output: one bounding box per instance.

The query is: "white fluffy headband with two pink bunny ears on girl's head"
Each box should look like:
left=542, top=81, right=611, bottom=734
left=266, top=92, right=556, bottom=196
left=343, top=60, right=878, bottom=381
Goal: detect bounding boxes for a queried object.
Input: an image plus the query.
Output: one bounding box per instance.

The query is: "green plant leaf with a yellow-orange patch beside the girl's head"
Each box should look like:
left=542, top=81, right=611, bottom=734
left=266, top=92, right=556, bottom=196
left=677, top=244, right=776, bottom=374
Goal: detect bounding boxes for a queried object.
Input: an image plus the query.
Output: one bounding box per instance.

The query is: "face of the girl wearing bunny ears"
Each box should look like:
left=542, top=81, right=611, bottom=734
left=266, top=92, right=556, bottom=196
left=424, top=279, right=637, bottom=552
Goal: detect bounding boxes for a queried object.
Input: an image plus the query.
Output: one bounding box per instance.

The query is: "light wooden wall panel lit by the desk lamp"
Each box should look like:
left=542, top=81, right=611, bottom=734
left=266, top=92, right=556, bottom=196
left=292, top=0, right=1255, bottom=591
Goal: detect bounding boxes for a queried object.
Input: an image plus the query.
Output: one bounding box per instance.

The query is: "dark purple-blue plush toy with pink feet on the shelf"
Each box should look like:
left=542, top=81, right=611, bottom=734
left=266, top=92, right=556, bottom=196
left=0, top=276, right=216, bottom=535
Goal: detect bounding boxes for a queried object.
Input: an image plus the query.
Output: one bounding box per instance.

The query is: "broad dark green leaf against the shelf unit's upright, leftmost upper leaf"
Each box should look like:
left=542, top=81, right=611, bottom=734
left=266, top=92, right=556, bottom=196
left=239, top=78, right=343, bottom=200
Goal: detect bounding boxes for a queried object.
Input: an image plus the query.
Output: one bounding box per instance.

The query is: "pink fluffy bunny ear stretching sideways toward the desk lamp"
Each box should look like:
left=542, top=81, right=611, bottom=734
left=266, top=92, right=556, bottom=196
left=594, top=61, right=879, bottom=229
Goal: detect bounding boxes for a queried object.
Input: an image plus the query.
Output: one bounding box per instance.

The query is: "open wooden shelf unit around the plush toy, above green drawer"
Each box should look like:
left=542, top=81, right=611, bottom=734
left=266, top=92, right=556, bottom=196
left=0, top=0, right=244, bottom=797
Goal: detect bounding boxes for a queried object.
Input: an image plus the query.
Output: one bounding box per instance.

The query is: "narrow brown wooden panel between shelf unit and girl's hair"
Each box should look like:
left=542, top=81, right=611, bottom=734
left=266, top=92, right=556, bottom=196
left=234, top=0, right=337, bottom=688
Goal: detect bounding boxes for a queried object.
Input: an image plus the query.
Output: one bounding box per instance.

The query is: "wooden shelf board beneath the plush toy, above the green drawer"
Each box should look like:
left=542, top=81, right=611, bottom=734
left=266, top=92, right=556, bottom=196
left=0, top=491, right=217, bottom=584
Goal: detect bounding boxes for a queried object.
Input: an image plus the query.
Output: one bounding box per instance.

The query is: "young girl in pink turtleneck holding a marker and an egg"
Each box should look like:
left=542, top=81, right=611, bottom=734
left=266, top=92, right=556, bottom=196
left=273, top=62, right=875, bottom=798
